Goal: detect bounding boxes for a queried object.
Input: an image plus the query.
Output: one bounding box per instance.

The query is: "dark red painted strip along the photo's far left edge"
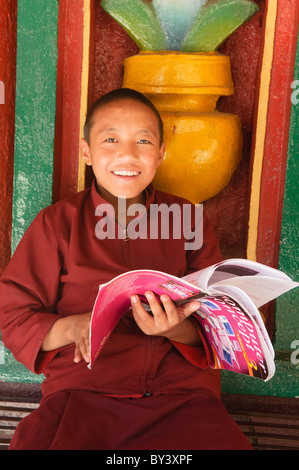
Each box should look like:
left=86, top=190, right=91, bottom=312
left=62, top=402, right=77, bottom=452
left=0, top=0, right=17, bottom=274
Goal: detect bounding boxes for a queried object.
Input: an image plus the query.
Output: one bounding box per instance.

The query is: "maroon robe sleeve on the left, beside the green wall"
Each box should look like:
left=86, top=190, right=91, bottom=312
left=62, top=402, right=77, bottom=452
left=0, top=210, right=61, bottom=373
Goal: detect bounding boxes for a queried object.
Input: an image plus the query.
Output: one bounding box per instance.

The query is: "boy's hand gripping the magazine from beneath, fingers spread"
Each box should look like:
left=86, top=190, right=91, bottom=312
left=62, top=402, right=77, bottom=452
left=131, top=292, right=201, bottom=346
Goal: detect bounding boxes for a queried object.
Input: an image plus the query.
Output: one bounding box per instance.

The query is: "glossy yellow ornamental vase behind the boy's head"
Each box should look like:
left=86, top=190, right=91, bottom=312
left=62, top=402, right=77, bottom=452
left=123, top=51, right=243, bottom=204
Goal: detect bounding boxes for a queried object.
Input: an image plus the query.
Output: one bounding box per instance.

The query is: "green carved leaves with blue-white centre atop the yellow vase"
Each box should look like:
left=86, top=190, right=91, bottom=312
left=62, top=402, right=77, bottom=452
left=101, top=0, right=259, bottom=52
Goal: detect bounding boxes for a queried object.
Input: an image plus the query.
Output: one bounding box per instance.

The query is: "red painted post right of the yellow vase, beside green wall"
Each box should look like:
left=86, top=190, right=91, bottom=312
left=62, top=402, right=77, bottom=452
left=256, top=0, right=299, bottom=267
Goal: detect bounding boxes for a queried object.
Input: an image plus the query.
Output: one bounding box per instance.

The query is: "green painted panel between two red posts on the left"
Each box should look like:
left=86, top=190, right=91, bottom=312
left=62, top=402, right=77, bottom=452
left=12, top=0, right=58, bottom=252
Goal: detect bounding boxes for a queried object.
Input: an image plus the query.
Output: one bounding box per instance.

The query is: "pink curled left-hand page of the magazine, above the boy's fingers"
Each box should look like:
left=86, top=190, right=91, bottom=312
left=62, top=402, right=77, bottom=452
left=89, top=270, right=204, bottom=367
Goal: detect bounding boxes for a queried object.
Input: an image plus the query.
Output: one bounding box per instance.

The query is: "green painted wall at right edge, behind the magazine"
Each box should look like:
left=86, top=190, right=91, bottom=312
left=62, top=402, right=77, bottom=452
left=222, top=37, right=299, bottom=398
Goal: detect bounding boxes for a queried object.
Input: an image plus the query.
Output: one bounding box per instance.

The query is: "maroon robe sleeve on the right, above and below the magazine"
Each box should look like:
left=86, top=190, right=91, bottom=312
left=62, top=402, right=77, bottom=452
left=172, top=208, right=222, bottom=369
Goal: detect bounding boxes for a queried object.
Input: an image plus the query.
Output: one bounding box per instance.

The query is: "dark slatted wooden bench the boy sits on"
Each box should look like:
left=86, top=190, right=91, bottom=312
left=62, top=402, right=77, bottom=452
left=0, top=384, right=299, bottom=450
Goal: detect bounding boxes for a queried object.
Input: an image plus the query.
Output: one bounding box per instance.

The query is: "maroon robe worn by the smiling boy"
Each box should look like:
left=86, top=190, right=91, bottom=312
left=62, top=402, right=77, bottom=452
left=0, top=184, right=250, bottom=450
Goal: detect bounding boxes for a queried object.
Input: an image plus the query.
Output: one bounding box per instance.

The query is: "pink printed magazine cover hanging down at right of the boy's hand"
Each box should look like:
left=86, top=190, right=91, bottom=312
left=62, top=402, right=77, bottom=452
left=196, top=294, right=275, bottom=381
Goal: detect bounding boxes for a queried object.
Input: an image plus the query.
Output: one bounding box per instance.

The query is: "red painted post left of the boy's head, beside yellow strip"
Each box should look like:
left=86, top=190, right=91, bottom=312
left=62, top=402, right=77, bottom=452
left=53, top=0, right=84, bottom=202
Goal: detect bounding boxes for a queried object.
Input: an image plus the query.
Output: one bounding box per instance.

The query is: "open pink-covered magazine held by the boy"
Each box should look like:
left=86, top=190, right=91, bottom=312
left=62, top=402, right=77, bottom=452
left=89, top=259, right=299, bottom=381
